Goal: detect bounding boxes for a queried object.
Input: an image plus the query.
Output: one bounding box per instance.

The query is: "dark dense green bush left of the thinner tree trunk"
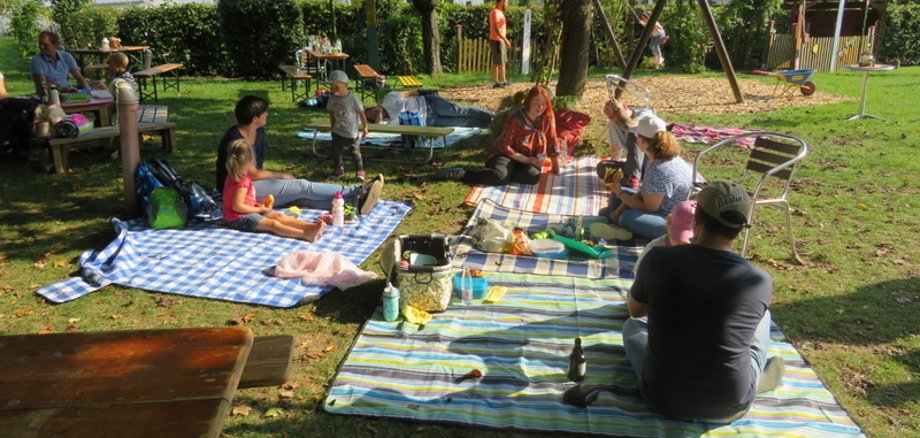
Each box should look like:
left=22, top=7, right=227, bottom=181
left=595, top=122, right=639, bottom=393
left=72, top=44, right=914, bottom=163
left=217, top=0, right=304, bottom=78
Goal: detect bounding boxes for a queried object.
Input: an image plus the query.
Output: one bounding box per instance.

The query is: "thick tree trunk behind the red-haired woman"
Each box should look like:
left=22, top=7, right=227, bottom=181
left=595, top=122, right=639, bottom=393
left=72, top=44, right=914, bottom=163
left=556, top=0, right=594, bottom=97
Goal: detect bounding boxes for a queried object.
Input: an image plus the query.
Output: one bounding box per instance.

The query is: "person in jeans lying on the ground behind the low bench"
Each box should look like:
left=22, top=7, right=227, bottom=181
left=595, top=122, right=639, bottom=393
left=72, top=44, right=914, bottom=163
left=366, top=90, right=495, bottom=128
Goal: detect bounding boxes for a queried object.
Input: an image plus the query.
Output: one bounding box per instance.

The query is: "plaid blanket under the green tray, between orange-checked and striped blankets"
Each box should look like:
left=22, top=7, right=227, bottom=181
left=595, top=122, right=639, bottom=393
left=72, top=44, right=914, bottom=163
left=451, top=199, right=645, bottom=279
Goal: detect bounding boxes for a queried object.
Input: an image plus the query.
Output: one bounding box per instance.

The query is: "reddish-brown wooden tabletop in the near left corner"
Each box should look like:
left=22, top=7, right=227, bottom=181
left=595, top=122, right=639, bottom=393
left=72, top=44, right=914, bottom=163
left=0, top=327, right=253, bottom=438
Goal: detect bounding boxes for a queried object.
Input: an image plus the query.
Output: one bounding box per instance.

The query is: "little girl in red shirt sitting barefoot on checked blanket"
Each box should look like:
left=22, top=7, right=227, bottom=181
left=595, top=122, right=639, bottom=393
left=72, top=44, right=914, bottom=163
left=223, top=140, right=326, bottom=242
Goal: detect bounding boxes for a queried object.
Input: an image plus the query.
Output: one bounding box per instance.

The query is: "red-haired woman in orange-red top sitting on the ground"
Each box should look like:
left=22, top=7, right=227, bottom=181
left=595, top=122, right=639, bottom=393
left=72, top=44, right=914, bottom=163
left=438, top=86, right=559, bottom=186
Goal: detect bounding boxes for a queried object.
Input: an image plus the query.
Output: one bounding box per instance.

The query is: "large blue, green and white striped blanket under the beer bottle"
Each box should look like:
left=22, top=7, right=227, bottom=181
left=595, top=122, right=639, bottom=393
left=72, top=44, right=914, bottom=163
left=324, top=273, right=863, bottom=437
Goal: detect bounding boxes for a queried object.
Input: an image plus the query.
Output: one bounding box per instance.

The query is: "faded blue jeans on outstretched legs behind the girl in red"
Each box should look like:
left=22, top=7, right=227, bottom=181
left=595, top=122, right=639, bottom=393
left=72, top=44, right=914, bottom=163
left=253, top=179, right=361, bottom=210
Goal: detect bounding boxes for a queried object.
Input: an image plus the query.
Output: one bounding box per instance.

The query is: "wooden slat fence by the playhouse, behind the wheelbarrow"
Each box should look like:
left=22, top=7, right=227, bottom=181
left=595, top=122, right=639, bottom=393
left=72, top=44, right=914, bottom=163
left=763, top=33, right=874, bottom=71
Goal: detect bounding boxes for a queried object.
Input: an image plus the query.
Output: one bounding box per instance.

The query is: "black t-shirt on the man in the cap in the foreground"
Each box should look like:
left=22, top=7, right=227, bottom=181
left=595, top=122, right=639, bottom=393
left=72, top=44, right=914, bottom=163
left=630, top=245, right=773, bottom=419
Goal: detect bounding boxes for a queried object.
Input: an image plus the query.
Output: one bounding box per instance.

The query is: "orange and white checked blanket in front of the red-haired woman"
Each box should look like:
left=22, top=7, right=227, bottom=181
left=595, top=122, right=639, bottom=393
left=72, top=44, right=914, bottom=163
left=463, top=155, right=608, bottom=215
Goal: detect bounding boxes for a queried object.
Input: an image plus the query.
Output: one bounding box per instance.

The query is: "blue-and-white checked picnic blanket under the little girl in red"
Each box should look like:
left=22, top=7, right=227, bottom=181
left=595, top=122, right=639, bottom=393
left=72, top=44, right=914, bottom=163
left=36, top=201, right=411, bottom=307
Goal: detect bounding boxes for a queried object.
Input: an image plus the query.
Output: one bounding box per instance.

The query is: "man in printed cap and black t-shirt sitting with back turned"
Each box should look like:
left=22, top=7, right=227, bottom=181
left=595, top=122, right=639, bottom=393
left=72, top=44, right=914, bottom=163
left=623, top=182, right=784, bottom=423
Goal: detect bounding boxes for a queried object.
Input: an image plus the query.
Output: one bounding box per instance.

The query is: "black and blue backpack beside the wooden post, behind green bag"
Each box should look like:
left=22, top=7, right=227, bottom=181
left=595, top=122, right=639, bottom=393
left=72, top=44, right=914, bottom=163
left=135, top=158, right=222, bottom=221
